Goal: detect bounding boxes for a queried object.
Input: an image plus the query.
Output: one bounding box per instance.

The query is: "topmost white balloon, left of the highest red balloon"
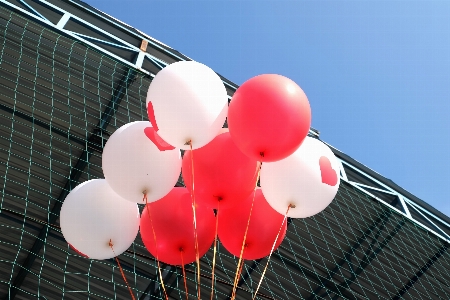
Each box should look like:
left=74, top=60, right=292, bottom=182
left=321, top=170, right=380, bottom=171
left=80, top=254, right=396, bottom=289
left=147, top=61, right=228, bottom=150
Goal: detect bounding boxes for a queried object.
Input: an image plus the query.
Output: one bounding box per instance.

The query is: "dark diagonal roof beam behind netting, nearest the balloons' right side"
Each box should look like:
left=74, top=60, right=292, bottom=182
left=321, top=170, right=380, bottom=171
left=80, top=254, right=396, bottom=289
left=308, top=209, right=392, bottom=300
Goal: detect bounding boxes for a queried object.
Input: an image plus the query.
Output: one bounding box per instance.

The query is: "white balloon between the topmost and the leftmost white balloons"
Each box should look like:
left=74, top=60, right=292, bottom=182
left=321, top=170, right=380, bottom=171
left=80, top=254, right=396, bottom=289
left=102, top=121, right=181, bottom=203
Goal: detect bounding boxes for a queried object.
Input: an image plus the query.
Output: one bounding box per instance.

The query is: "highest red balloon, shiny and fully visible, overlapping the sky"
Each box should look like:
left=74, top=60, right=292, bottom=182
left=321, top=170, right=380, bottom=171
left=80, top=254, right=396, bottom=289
left=228, top=74, right=311, bottom=162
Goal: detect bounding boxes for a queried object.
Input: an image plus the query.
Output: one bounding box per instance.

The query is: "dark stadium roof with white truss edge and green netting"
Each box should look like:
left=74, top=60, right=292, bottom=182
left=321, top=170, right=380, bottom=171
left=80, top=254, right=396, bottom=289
left=0, top=0, right=450, bottom=300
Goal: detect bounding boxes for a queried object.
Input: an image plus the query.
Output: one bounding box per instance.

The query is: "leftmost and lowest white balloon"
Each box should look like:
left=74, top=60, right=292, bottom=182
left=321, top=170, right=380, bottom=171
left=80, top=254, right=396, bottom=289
left=60, top=179, right=139, bottom=259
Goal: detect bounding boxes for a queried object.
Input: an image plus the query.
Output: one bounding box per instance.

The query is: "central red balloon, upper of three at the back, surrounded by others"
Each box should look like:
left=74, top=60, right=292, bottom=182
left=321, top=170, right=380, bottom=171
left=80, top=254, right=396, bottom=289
left=182, top=132, right=259, bottom=209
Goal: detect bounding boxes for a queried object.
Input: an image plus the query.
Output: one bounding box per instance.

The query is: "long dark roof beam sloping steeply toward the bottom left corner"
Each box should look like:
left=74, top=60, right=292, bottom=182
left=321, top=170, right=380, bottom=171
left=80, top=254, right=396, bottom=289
left=7, top=68, right=137, bottom=300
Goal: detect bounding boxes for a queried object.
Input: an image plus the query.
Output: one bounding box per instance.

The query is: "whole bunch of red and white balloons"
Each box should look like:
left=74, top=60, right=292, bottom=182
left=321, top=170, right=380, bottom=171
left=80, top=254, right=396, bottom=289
left=60, top=61, right=339, bottom=276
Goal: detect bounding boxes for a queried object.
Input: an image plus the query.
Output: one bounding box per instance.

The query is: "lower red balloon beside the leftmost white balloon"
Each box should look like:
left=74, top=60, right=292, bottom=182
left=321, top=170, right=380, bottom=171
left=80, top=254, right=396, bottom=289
left=140, top=187, right=215, bottom=265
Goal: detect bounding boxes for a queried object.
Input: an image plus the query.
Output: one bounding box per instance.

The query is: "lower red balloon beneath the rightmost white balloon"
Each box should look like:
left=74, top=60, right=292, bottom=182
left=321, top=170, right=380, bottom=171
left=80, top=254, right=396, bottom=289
left=218, top=189, right=287, bottom=260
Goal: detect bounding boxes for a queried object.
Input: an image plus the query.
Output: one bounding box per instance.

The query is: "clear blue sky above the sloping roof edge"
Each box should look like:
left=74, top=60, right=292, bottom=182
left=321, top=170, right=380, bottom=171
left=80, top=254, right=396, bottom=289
left=86, top=0, right=450, bottom=215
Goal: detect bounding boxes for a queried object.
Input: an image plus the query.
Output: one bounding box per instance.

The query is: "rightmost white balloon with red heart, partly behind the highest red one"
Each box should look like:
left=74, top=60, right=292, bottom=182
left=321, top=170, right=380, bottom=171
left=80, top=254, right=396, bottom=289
left=261, top=137, right=340, bottom=218
